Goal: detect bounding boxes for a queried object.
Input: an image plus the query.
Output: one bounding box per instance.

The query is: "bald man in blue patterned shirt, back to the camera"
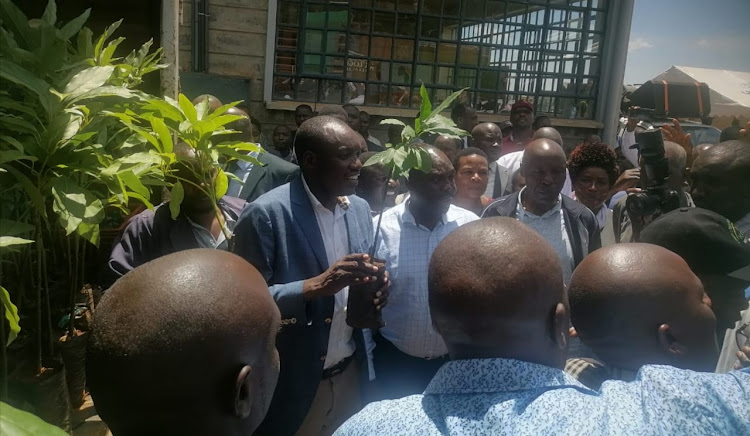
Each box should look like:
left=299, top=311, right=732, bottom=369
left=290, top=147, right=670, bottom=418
left=336, top=218, right=750, bottom=436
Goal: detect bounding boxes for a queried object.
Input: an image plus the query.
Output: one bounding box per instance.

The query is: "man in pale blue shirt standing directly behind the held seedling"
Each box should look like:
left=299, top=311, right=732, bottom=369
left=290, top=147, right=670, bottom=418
left=374, top=146, right=479, bottom=399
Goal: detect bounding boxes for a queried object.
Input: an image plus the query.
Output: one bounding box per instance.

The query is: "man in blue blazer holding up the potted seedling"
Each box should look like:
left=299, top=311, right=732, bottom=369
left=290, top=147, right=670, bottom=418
left=235, top=116, right=388, bottom=435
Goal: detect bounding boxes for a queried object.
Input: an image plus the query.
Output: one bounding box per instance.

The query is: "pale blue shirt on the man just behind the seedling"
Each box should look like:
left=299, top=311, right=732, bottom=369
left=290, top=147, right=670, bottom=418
left=375, top=201, right=479, bottom=358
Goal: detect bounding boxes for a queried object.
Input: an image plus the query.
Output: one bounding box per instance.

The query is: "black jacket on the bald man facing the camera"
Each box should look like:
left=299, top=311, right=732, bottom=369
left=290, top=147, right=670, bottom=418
left=482, top=192, right=602, bottom=268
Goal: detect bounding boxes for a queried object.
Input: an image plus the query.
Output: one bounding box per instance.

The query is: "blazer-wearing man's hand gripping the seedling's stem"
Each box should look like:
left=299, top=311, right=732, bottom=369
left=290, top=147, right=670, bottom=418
left=302, top=253, right=378, bottom=300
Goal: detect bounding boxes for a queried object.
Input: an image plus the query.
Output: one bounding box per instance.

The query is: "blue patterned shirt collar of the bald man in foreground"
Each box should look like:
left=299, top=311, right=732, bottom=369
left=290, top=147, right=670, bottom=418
left=425, top=358, right=588, bottom=395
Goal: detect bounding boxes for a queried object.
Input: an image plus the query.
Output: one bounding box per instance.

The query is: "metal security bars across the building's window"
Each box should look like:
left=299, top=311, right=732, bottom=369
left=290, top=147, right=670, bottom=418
left=272, top=0, right=611, bottom=119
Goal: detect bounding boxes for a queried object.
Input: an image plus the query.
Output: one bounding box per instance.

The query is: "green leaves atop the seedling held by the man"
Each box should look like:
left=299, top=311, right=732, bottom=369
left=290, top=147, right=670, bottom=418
left=365, top=85, right=469, bottom=178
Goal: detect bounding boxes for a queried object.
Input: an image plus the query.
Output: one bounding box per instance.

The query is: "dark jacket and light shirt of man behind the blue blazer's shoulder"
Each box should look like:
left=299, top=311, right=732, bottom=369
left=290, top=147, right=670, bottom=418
left=227, top=152, right=299, bottom=202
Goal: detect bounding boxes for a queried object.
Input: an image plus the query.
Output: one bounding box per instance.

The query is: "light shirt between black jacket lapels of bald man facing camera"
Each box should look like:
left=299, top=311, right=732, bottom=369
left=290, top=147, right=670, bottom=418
left=516, top=188, right=574, bottom=286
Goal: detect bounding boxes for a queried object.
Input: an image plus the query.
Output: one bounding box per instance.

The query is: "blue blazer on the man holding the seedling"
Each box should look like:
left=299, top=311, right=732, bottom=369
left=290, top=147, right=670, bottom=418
left=234, top=177, right=373, bottom=435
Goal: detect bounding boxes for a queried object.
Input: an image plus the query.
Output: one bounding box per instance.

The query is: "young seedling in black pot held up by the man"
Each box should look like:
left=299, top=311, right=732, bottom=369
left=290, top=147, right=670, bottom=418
left=346, top=85, right=469, bottom=329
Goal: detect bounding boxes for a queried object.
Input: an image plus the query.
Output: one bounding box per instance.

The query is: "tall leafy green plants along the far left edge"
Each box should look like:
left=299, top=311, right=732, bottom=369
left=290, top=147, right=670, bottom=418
left=0, top=0, right=164, bottom=372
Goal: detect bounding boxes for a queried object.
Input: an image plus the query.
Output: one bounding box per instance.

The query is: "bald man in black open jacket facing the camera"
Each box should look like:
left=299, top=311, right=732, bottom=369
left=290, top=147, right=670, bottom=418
left=482, top=139, right=601, bottom=284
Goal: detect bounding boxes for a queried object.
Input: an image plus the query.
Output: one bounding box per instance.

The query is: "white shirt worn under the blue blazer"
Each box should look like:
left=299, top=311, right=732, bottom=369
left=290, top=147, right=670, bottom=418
left=302, top=177, right=355, bottom=369
